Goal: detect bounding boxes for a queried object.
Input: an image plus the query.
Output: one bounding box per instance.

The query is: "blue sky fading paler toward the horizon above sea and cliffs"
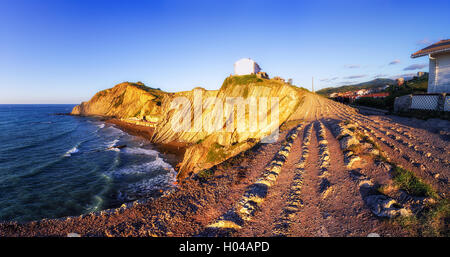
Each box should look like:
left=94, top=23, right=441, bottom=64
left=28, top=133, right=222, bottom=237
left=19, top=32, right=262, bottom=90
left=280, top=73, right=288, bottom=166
left=0, top=0, right=450, bottom=104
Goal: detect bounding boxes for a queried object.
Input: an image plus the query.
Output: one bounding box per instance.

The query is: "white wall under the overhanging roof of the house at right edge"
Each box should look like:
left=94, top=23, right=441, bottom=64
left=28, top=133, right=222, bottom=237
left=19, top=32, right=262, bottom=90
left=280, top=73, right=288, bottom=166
left=428, top=53, right=450, bottom=93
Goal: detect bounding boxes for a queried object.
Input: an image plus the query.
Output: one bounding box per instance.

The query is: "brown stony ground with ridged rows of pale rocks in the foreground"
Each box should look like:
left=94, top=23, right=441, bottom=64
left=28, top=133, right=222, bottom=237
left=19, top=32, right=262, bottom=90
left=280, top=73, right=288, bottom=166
left=0, top=94, right=450, bottom=236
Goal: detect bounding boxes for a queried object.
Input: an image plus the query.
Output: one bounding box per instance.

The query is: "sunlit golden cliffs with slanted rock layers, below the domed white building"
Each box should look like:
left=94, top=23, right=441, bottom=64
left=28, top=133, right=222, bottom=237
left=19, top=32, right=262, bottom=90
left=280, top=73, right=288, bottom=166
left=72, top=75, right=307, bottom=179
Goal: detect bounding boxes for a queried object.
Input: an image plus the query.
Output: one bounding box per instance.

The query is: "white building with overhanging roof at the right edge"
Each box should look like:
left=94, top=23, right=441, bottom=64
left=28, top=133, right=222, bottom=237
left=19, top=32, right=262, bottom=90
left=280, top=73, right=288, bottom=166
left=411, top=39, right=450, bottom=94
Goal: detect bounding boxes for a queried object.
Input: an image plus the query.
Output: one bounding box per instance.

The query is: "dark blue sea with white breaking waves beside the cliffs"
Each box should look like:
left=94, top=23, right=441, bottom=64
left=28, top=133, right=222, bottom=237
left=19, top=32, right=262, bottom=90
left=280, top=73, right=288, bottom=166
left=0, top=105, right=176, bottom=221
